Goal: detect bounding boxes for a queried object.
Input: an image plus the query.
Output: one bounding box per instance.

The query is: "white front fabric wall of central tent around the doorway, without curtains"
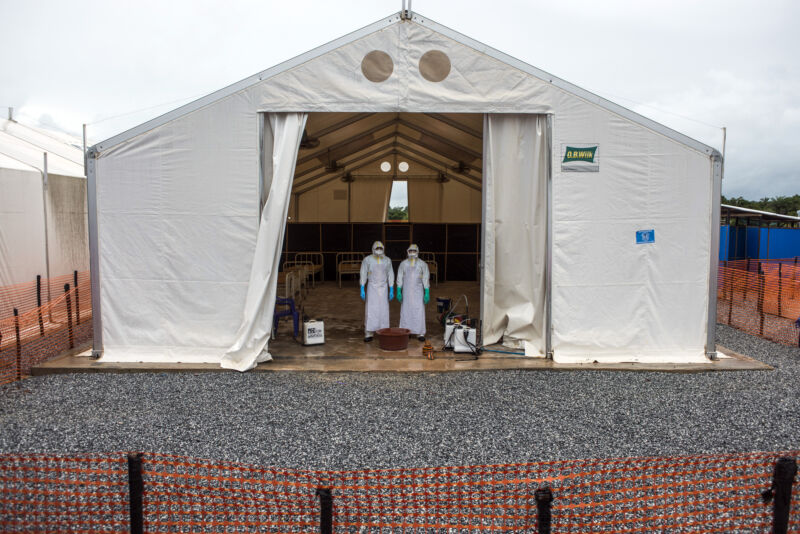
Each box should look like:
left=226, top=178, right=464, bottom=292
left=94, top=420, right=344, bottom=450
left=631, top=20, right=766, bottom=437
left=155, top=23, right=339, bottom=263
left=90, top=14, right=716, bottom=361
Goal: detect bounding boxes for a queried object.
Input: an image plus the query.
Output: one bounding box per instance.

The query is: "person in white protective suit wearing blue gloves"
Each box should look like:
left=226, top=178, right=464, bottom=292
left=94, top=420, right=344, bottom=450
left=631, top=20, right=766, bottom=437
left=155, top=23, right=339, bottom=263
left=360, top=241, right=394, bottom=342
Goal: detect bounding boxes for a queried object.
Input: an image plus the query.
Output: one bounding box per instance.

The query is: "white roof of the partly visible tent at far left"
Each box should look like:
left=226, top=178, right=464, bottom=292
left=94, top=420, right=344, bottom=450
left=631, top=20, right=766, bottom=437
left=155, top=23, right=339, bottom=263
left=0, top=119, right=84, bottom=178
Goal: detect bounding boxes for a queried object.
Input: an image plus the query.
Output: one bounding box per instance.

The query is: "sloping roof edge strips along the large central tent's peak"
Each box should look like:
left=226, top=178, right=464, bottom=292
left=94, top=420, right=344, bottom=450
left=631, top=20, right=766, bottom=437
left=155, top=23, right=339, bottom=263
left=91, top=11, right=719, bottom=159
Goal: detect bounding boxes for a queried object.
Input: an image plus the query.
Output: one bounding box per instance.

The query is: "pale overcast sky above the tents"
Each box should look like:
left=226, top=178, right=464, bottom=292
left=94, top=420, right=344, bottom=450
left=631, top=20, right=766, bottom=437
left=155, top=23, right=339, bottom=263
left=0, top=0, right=800, bottom=199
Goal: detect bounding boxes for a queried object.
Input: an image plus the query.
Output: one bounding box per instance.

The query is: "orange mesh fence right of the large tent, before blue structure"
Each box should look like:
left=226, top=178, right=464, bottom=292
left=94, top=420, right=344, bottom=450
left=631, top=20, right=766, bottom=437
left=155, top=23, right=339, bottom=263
left=717, top=258, right=800, bottom=346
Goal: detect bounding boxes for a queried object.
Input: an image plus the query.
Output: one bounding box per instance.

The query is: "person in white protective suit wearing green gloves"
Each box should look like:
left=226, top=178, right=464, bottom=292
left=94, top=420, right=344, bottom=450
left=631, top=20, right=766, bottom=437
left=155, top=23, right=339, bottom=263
left=397, top=245, right=431, bottom=341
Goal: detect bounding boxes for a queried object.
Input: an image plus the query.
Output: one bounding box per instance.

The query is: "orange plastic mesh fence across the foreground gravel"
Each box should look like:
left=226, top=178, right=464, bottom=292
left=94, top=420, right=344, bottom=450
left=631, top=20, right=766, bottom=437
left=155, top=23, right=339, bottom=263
left=0, top=451, right=800, bottom=533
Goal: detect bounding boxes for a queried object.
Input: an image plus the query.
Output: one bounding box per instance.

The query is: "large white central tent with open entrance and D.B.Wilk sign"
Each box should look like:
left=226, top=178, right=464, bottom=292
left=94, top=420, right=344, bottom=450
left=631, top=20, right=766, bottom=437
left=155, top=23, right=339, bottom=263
left=88, top=11, right=721, bottom=370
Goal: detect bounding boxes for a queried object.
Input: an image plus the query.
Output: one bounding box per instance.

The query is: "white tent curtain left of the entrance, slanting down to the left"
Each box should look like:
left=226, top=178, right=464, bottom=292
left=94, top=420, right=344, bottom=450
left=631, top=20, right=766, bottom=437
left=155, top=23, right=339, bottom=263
left=221, top=113, right=308, bottom=371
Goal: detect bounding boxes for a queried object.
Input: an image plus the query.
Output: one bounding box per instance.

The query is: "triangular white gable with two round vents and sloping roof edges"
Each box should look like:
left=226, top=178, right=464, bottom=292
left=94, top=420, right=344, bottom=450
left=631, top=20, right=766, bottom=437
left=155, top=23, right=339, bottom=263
left=97, top=13, right=716, bottom=155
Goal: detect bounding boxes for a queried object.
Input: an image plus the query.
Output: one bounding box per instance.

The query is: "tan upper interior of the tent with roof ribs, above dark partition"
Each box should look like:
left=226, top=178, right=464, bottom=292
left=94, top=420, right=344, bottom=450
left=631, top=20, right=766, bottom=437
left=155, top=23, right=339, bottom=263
left=290, top=113, right=483, bottom=222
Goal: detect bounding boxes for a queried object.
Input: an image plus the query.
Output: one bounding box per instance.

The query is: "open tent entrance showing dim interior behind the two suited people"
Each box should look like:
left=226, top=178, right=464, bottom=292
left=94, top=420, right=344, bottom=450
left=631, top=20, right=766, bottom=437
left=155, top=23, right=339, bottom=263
left=270, top=113, right=484, bottom=359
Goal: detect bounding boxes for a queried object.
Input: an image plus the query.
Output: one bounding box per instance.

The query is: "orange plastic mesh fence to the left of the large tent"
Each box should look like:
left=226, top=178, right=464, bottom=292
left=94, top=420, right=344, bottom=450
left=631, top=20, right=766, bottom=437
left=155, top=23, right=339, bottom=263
left=0, top=274, right=92, bottom=384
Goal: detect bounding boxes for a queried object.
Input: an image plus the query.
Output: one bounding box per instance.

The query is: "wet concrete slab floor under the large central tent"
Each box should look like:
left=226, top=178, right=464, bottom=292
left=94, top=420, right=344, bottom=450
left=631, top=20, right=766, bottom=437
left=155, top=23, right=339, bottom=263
left=32, top=280, right=771, bottom=375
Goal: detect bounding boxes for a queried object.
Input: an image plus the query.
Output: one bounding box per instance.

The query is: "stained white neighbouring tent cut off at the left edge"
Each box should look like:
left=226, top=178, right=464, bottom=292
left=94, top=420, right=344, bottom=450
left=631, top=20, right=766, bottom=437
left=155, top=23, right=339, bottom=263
left=0, top=117, right=89, bottom=316
